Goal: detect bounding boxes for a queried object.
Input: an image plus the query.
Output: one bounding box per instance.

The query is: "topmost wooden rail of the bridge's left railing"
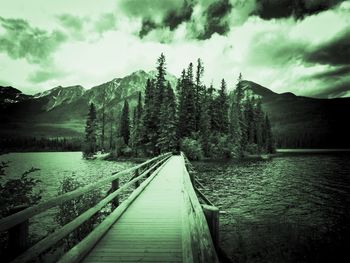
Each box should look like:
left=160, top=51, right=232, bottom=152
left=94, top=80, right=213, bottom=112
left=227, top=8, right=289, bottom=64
left=0, top=153, right=171, bottom=232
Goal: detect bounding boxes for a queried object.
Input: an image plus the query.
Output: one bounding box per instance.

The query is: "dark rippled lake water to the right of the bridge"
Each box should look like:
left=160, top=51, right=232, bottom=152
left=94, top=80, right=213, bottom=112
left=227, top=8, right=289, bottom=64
left=195, top=153, right=350, bottom=262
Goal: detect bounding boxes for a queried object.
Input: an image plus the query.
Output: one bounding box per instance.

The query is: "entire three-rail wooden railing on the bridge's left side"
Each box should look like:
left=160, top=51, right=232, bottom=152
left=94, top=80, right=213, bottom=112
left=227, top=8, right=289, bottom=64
left=0, top=153, right=171, bottom=262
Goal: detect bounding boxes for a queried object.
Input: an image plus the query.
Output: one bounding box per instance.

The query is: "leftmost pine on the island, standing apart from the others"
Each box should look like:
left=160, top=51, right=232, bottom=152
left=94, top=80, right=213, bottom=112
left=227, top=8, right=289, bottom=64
left=83, top=103, right=97, bottom=157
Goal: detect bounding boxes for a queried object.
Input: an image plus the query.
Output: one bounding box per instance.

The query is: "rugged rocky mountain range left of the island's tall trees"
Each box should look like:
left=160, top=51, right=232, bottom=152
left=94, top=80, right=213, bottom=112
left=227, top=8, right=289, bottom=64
left=0, top=70, right=176, bottom=137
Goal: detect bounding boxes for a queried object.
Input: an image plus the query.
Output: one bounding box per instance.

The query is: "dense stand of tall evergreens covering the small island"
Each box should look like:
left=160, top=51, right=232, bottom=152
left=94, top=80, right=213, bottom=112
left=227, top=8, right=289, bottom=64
left=83, top=54, right=275, bottom=159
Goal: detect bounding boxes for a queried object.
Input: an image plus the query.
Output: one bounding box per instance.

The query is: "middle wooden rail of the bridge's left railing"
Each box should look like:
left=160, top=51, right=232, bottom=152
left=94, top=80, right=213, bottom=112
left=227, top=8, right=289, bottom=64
left=12, top=156, right=169, bottom=263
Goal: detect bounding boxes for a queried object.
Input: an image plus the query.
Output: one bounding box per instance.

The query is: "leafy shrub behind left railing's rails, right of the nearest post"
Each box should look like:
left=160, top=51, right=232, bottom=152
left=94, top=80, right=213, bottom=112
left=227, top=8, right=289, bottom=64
left=55, top=176, right=101, bottom=250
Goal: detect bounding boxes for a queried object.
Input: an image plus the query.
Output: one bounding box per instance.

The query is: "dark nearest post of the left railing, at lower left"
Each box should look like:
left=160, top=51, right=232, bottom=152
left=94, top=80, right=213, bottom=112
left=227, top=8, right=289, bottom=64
left=8, top=205, right=29, bottom=257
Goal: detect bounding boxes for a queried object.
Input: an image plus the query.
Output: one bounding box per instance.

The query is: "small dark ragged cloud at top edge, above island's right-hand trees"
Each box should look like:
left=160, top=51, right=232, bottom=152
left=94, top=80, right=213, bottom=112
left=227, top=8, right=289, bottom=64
left=198, top=0, right=232, bottom=39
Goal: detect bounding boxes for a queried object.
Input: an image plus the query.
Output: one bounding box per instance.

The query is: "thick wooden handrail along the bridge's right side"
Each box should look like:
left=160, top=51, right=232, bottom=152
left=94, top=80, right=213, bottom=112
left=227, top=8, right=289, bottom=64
left=181, top=153, right=219, bottom=262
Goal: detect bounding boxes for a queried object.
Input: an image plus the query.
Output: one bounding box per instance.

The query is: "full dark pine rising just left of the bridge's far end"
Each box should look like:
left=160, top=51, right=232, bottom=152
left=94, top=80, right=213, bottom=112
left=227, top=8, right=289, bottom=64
left=157, top=82, right=177, bottom=153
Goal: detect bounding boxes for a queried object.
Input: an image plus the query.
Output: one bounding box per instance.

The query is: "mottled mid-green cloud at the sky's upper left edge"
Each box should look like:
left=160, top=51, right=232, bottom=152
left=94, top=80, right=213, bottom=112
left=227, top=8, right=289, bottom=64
left=0, top=17, right=67, bottom=64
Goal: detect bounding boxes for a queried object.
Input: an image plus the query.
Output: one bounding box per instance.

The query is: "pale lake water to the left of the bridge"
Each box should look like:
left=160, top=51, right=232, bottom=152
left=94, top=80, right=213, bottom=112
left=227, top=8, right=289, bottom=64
left=0, top=152, right=133, bottom=239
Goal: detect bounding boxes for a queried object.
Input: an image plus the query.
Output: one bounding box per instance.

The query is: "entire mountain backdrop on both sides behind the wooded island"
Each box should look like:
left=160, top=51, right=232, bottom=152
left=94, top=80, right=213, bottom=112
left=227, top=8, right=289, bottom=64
left=0, top=73, right=350, bottom=148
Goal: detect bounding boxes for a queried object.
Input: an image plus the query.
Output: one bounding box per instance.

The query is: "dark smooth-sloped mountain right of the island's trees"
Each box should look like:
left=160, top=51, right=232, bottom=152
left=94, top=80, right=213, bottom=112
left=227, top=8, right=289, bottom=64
left=243, top=81, right=350, bottom=148
